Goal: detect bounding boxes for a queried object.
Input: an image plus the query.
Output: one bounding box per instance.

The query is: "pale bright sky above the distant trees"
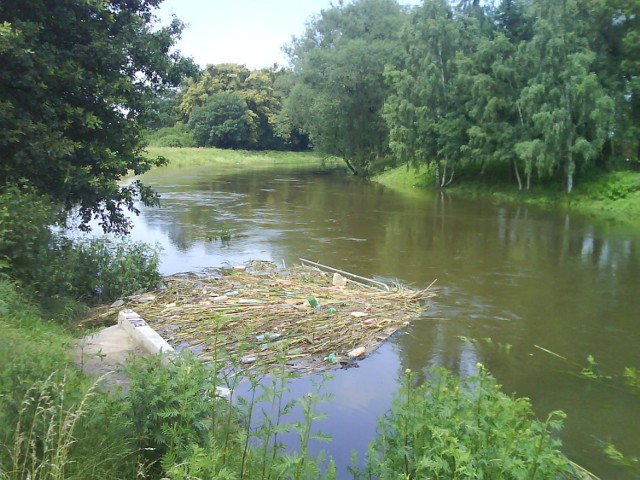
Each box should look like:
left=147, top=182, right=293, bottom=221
left=156, top=0, right=418, bottom=69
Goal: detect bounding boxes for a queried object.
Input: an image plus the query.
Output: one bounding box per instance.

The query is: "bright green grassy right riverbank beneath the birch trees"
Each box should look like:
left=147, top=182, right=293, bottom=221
left=373, top=166, right=640, bottom=224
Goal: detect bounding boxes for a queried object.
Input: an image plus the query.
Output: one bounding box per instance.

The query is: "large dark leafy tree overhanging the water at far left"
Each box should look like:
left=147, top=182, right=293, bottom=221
left=0, top=0, right=184, bottom=231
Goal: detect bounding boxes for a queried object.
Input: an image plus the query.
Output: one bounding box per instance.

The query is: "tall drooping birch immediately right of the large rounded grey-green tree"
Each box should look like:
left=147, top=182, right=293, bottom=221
left=384, top=0, right=477, bottom=186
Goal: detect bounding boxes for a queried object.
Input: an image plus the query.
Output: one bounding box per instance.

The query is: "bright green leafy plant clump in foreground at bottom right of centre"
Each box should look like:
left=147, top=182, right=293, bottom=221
left=365, top=367, right=570, bottom=479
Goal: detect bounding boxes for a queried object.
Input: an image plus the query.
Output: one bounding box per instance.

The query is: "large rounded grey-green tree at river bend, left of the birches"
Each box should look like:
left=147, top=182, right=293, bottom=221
left=284, top=0, right=406, bottom=176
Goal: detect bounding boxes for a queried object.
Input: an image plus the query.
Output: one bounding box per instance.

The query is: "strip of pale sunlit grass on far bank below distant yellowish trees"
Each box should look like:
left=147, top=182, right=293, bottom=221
left=147, top=146, right=342, bottom=168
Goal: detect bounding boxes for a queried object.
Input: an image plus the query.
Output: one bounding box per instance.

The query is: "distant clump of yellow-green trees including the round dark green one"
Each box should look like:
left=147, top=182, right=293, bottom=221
left=147, top=63, right=309, bottom=150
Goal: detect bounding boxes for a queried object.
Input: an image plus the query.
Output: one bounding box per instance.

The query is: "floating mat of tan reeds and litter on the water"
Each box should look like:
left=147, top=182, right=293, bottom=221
left=100, top=261, right=434, bottom=373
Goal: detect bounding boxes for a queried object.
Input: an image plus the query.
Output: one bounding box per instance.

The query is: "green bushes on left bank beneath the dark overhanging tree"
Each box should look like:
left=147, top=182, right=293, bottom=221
left=0, top=182, right=160, bottom=306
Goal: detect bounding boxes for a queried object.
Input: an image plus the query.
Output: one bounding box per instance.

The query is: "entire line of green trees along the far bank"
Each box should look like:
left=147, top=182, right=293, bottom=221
left=152, top=0, right=640, bottom=191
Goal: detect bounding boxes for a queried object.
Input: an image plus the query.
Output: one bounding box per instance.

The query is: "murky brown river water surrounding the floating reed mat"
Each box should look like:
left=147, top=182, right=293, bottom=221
left=126, top=163, right=640, bottom=480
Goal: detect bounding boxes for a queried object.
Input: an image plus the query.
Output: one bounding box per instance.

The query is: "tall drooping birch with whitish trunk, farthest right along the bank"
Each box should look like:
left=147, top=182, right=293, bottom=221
left=515, top=0, right=614, bottom=193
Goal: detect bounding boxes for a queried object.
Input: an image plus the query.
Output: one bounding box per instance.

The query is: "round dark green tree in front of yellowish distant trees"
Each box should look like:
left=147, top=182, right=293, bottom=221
left=187, top=92, right=255, bottom=148
